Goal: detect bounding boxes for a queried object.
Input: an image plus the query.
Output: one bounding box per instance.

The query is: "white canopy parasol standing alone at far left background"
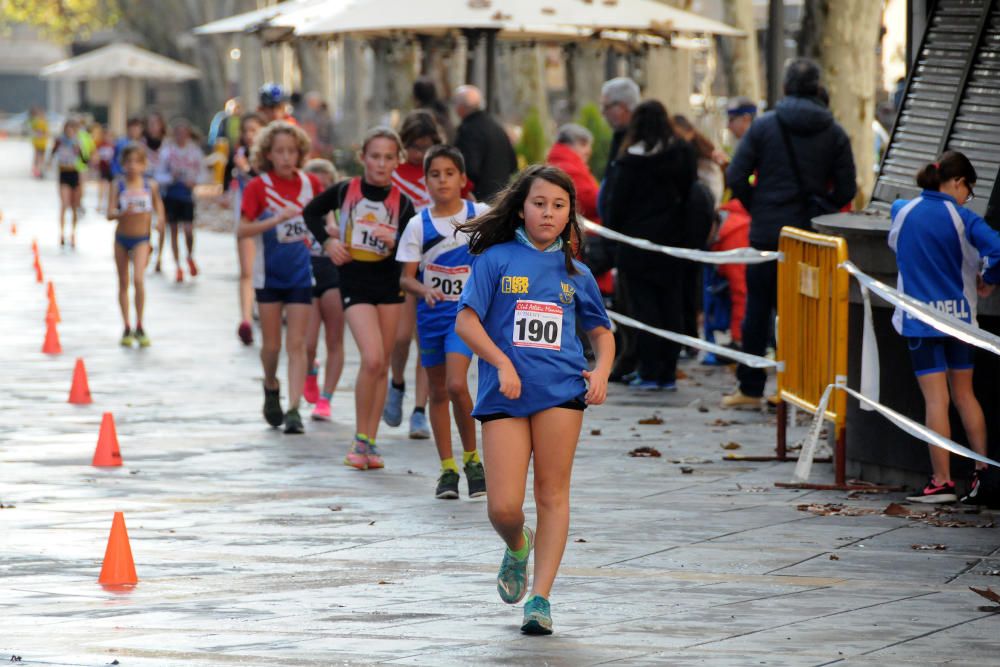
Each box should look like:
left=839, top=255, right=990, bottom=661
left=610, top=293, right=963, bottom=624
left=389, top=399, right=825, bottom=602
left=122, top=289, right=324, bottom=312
left=40, top=43, right=201, bottom=134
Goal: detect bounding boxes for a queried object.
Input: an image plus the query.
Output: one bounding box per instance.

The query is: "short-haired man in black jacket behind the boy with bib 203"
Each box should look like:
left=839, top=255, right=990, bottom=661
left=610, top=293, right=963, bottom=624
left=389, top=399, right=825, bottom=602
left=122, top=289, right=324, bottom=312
left=454, top=86, right=517, bottom=202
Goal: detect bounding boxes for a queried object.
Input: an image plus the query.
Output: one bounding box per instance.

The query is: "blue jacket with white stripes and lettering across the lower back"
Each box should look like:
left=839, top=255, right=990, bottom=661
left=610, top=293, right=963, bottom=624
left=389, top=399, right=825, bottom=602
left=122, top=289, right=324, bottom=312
left=889, top=190, right=1000, bottom=337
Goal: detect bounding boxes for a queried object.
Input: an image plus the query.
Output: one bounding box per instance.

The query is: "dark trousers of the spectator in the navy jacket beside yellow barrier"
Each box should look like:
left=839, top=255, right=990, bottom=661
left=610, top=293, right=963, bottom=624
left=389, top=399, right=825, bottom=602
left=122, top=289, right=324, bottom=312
left=736, top=262, right=778, bottom=397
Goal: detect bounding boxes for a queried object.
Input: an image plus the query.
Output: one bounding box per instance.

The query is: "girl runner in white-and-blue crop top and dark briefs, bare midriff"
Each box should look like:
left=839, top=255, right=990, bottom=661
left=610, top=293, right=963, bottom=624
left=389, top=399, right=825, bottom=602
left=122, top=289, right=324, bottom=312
left=107, top=144, right=166, bottom=347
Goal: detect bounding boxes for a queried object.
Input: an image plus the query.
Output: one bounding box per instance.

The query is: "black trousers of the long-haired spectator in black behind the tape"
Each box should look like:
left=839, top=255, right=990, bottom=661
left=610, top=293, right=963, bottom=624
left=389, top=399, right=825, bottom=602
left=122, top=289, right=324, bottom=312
left=625, top=263, right=684, bottom=384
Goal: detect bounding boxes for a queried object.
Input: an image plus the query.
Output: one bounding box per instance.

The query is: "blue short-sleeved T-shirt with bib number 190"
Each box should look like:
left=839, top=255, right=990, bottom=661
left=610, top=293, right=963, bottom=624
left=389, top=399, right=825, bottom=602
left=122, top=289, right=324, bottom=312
left=458, top=241, right=611, bottom=417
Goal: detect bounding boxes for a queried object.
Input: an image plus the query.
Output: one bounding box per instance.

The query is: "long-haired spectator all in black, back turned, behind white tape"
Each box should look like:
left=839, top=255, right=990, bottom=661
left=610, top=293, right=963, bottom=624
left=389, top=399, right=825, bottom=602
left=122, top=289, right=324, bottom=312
left=604, top=100, right=698, bottom=390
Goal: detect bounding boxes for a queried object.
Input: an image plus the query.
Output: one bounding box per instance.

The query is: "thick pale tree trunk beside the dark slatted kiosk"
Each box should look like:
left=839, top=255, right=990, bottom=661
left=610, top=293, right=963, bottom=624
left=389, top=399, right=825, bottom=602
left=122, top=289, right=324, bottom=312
left=820, top=0, right=882, bottom=208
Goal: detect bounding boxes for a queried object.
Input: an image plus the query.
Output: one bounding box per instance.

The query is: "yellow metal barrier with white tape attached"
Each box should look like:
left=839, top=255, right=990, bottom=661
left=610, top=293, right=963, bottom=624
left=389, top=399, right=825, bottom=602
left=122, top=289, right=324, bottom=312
left=777, top=227, right=850, bottom=485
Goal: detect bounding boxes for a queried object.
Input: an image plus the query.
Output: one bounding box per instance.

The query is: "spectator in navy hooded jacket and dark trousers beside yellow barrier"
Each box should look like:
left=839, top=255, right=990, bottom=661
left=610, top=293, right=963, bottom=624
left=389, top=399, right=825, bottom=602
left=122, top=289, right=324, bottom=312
left=723, top=58, right=857, bottom=407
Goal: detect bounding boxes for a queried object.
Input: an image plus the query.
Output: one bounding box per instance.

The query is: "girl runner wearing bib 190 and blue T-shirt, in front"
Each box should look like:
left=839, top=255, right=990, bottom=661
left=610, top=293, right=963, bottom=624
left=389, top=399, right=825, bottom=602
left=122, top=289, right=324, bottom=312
left=455, top=165, right=615, bottom=634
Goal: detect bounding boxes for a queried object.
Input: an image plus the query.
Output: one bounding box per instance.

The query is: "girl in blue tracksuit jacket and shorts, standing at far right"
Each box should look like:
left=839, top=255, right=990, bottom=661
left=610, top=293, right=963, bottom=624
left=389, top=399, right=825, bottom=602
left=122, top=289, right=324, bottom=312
left=889, top=151, right=1000, bottom=503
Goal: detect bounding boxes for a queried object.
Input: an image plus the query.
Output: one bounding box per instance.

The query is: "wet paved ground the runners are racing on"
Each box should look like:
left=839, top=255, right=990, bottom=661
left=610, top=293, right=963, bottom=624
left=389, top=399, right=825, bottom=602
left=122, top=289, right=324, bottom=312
left=0, top=141, right=1000, bottom=667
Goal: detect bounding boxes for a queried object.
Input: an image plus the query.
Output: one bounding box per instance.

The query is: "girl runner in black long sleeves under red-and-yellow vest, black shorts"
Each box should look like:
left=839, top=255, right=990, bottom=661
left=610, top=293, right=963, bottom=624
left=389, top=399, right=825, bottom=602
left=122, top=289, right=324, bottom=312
left=302, top=127, right=414, bottom=470
